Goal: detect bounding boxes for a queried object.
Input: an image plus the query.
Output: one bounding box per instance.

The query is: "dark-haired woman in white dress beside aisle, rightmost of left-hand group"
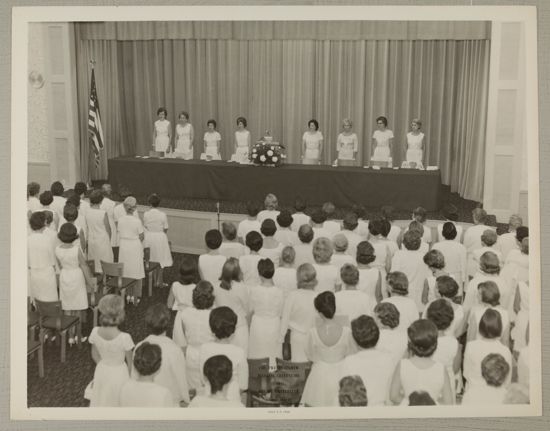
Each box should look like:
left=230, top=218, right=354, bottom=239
left=143, top=193, right=173, bottom=287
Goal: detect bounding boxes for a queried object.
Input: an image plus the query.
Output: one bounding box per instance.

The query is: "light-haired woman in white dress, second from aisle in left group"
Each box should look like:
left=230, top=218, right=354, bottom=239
left=117, top=196, right=145, bottom=305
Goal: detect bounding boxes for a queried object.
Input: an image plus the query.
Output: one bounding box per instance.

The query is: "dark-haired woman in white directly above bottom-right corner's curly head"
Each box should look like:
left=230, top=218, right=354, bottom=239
left=463, top=309, right=512, bottom=390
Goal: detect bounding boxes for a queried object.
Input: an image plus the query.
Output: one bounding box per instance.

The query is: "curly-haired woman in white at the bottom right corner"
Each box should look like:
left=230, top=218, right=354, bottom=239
left=462, top=353, right=511, bottom=406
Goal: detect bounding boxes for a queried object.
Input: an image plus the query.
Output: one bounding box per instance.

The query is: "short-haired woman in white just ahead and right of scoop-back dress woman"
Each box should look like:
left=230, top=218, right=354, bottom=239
left=335, top=263, right=376, bottom=322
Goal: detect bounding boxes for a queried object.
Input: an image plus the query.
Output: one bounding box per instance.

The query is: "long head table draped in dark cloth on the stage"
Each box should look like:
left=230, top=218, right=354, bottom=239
left=109, top=157, right=441, bottom=211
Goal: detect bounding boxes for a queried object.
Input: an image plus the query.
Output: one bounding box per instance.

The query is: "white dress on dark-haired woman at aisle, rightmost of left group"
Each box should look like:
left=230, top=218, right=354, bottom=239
left=143, top=208, right=173, bottom=268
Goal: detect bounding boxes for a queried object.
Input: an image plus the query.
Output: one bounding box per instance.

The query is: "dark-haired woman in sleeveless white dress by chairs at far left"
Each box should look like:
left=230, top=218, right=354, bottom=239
left=55, top=223, right=93, bottom=344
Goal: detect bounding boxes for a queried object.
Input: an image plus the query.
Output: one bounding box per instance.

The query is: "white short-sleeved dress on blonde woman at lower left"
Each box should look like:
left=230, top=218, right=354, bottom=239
left=88, top=326, right=134, bottom=407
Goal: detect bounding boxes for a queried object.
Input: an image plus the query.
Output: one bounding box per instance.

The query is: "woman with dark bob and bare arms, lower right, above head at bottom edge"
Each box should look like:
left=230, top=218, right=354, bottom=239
left=390, top=319, right=454, bottom=405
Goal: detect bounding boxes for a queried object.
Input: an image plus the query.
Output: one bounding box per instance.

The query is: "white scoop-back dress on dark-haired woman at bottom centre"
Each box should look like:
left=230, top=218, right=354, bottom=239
left=300, top=326, right=350, bottom=407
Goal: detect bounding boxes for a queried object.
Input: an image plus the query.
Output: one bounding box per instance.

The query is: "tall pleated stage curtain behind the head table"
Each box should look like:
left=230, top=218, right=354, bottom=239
left=77, top=35, right=490, bottom=201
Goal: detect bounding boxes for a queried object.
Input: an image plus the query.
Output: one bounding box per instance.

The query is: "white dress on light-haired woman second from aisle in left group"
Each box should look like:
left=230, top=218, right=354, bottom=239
left=118, top=215, right=145, bottom=280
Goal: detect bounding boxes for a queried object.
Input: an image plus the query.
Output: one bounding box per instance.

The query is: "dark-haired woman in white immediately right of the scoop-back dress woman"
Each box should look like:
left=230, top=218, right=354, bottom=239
left=340, top=315, right=395, bottom=406
